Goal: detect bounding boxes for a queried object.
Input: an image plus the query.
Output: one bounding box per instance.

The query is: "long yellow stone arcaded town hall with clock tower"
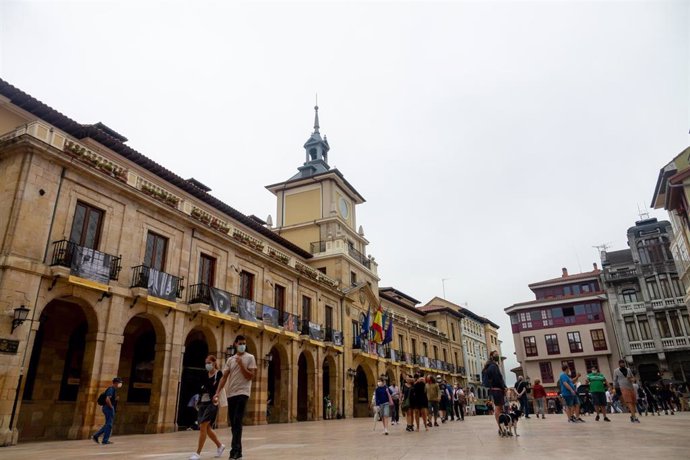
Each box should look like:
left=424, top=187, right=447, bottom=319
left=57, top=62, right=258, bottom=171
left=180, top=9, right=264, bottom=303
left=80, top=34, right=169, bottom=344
left=0, top=80, right=484, bottom=445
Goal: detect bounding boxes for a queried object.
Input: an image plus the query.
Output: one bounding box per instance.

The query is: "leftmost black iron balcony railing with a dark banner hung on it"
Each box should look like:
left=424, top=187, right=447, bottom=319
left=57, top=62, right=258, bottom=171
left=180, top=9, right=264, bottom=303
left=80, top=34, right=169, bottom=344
left=50, top=240, right=122, bottom=283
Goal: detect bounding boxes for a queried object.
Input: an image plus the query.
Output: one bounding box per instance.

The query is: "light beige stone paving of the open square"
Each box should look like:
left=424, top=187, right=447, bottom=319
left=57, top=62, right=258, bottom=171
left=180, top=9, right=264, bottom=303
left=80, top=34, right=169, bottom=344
left=5, top=412, right=690, bottom=460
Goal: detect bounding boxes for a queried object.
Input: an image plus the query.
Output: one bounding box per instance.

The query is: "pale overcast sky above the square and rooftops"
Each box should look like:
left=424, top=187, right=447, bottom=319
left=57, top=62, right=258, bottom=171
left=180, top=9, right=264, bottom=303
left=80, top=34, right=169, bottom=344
left=0, top=0, right=690, bottom=380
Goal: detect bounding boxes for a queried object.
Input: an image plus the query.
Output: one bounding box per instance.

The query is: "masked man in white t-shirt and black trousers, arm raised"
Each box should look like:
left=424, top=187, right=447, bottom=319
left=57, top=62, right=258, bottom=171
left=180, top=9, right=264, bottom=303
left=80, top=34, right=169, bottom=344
left=213, top=335, right=256, bottom=459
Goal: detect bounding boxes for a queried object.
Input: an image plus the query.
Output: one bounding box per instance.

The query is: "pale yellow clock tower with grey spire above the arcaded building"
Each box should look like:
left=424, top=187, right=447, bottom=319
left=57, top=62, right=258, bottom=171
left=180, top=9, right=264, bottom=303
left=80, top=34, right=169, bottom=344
left=266, top=106, right=378, bottom=292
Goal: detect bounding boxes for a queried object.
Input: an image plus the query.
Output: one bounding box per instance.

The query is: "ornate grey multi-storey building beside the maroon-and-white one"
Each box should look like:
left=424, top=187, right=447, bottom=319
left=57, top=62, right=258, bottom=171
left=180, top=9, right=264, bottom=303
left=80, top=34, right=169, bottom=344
left=601, top=218, right=690, bottom=382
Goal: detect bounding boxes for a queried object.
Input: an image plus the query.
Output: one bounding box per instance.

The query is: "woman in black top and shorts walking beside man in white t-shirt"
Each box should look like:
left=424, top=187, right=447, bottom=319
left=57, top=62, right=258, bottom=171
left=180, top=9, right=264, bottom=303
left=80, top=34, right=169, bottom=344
left=189, top=355, right=225, bottom=460
